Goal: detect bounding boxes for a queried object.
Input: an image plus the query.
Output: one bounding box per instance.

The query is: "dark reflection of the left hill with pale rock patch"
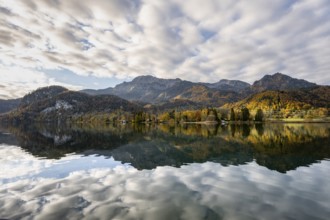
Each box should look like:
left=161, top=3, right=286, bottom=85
left=0, top=126, right=138, bottom=159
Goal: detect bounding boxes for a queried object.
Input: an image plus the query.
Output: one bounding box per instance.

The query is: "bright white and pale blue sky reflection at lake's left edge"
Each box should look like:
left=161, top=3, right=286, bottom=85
left=0, top=145, right=126, bottom=180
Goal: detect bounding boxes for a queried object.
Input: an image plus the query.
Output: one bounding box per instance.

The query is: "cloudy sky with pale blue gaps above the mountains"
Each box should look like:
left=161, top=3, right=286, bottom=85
left=0, top=0, right=330, bottom=99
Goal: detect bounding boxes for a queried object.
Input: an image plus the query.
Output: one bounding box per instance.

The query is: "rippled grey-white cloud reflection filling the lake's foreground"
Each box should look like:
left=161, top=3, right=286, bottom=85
left=0, top=144, right=330, bottom=219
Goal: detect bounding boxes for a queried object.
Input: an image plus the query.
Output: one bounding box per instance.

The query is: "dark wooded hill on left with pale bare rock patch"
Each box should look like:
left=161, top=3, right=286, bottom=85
left=2, top=86, right=142, bottom=122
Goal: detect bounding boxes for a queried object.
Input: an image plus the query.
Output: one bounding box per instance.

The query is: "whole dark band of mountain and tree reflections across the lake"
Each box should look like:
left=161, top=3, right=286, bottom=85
left=1, top=124, right=330, bottom=172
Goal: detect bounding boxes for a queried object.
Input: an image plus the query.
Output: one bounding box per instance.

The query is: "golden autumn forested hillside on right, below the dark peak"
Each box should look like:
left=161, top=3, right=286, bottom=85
left=222, top=86, right=330, bottom=119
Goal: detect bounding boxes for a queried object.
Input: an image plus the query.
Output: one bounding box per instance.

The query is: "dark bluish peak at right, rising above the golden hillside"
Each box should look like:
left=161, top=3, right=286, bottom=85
left=251, top=73, right=317, bottom=93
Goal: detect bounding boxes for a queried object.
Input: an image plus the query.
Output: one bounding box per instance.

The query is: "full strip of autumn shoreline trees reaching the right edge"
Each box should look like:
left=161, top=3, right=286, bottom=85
left=71, top=107, right=329, bottom=124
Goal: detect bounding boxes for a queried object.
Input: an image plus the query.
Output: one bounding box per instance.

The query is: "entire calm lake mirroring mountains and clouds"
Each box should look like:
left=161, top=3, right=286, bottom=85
left=0, top=123, right=330, bottom=220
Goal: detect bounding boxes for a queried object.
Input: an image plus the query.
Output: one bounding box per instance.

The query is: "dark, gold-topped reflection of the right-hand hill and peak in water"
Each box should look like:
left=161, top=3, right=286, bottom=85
left=248, top=124, right=330, bottom=172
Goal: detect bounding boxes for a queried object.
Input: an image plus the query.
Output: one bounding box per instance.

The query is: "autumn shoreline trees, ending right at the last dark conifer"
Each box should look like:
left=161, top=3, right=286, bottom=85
left=71, top=108, right=265, bottom=124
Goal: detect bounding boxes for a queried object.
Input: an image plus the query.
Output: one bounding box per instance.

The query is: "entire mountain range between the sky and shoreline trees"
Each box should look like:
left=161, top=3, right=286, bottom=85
left=0, top=73, right=330, bottom=120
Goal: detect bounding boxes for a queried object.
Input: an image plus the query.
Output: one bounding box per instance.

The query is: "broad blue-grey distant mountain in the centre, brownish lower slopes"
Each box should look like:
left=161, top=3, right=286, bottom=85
left=82, top=76, right=242, bottom=106
